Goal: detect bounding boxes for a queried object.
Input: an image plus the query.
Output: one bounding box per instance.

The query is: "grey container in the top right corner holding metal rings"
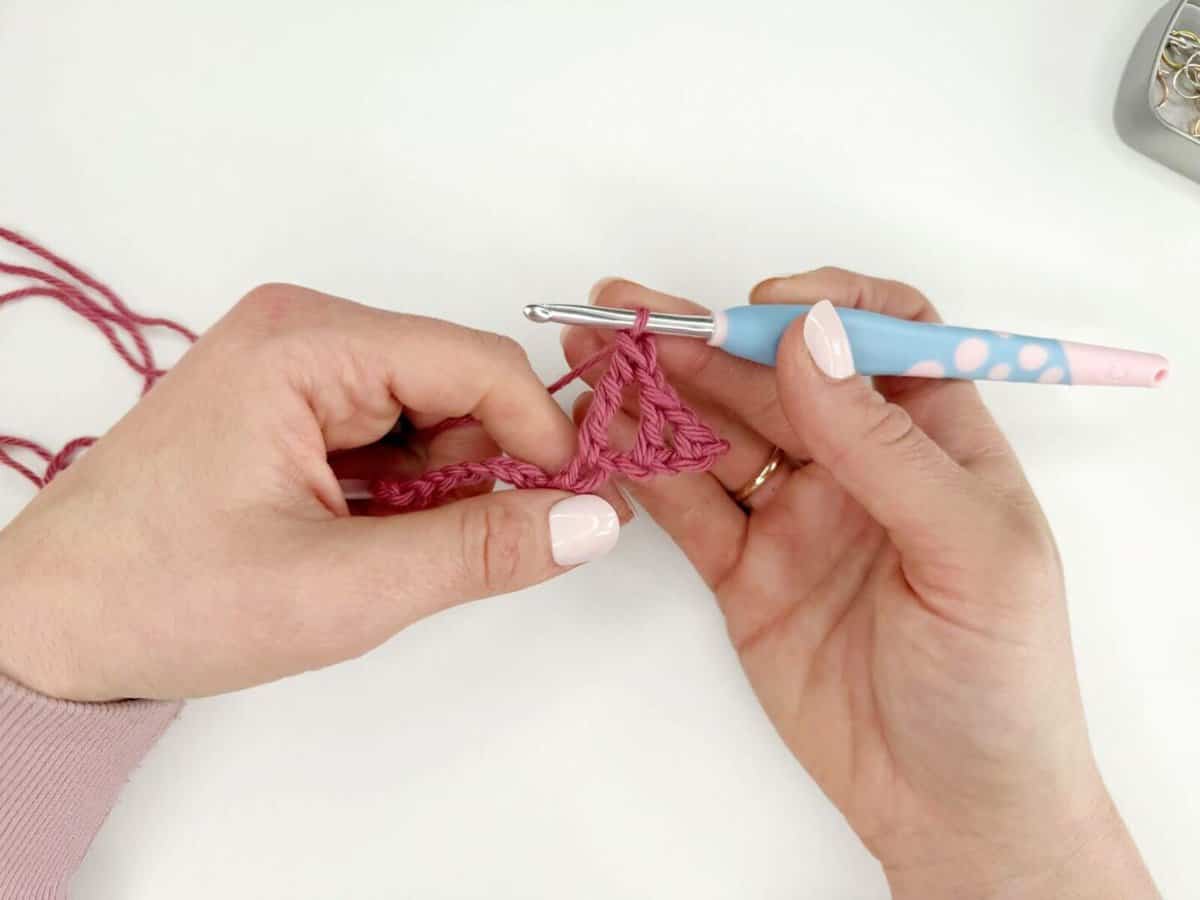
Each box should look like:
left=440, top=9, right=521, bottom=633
left=1114, top=0, right=1200, bottom=181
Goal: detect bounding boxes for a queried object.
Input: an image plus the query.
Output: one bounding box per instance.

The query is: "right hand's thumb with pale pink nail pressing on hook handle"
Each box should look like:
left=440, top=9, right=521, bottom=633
left=776, top=300, right=983, bottom=552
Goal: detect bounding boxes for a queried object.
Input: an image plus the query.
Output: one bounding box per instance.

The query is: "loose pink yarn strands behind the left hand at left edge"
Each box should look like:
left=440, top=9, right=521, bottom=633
left=0, top=227, right=196, bottom=487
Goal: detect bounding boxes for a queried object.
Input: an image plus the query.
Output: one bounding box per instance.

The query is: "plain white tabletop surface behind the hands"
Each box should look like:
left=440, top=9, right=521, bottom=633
left=0, top=0, right=1200, bottom=900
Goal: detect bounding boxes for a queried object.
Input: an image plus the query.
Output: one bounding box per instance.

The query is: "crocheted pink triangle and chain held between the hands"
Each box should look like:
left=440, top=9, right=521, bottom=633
left=371, top=310, right=730, bottom=510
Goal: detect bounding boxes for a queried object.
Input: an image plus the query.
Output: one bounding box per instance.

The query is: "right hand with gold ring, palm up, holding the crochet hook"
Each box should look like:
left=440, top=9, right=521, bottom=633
left=564, top=269, right=1157, bottom=900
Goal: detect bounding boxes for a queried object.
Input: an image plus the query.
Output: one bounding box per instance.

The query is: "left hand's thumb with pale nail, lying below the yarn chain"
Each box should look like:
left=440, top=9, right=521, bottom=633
left=342, top=490, right=620, bottom=618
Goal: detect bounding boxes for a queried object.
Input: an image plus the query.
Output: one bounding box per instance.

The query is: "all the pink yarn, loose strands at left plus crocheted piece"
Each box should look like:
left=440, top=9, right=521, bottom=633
left=0, top=228, right=728, bottom=511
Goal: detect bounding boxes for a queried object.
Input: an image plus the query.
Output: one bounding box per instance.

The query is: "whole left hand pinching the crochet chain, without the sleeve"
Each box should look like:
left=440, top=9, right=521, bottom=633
left=0, top=284, right=629, bottom=701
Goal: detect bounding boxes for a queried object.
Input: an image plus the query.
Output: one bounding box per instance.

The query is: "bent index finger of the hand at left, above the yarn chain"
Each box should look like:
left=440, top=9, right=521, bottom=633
left=226, top=284, right=576, bottom=482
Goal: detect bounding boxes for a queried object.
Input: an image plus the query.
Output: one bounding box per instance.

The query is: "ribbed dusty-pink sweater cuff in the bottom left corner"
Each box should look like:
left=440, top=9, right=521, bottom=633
left=0, top=676, right=181, bottom=900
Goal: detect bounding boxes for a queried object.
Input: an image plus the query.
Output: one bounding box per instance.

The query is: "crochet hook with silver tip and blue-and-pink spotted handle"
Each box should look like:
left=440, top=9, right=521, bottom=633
left=524, top=304, right=1169, bottom=388
